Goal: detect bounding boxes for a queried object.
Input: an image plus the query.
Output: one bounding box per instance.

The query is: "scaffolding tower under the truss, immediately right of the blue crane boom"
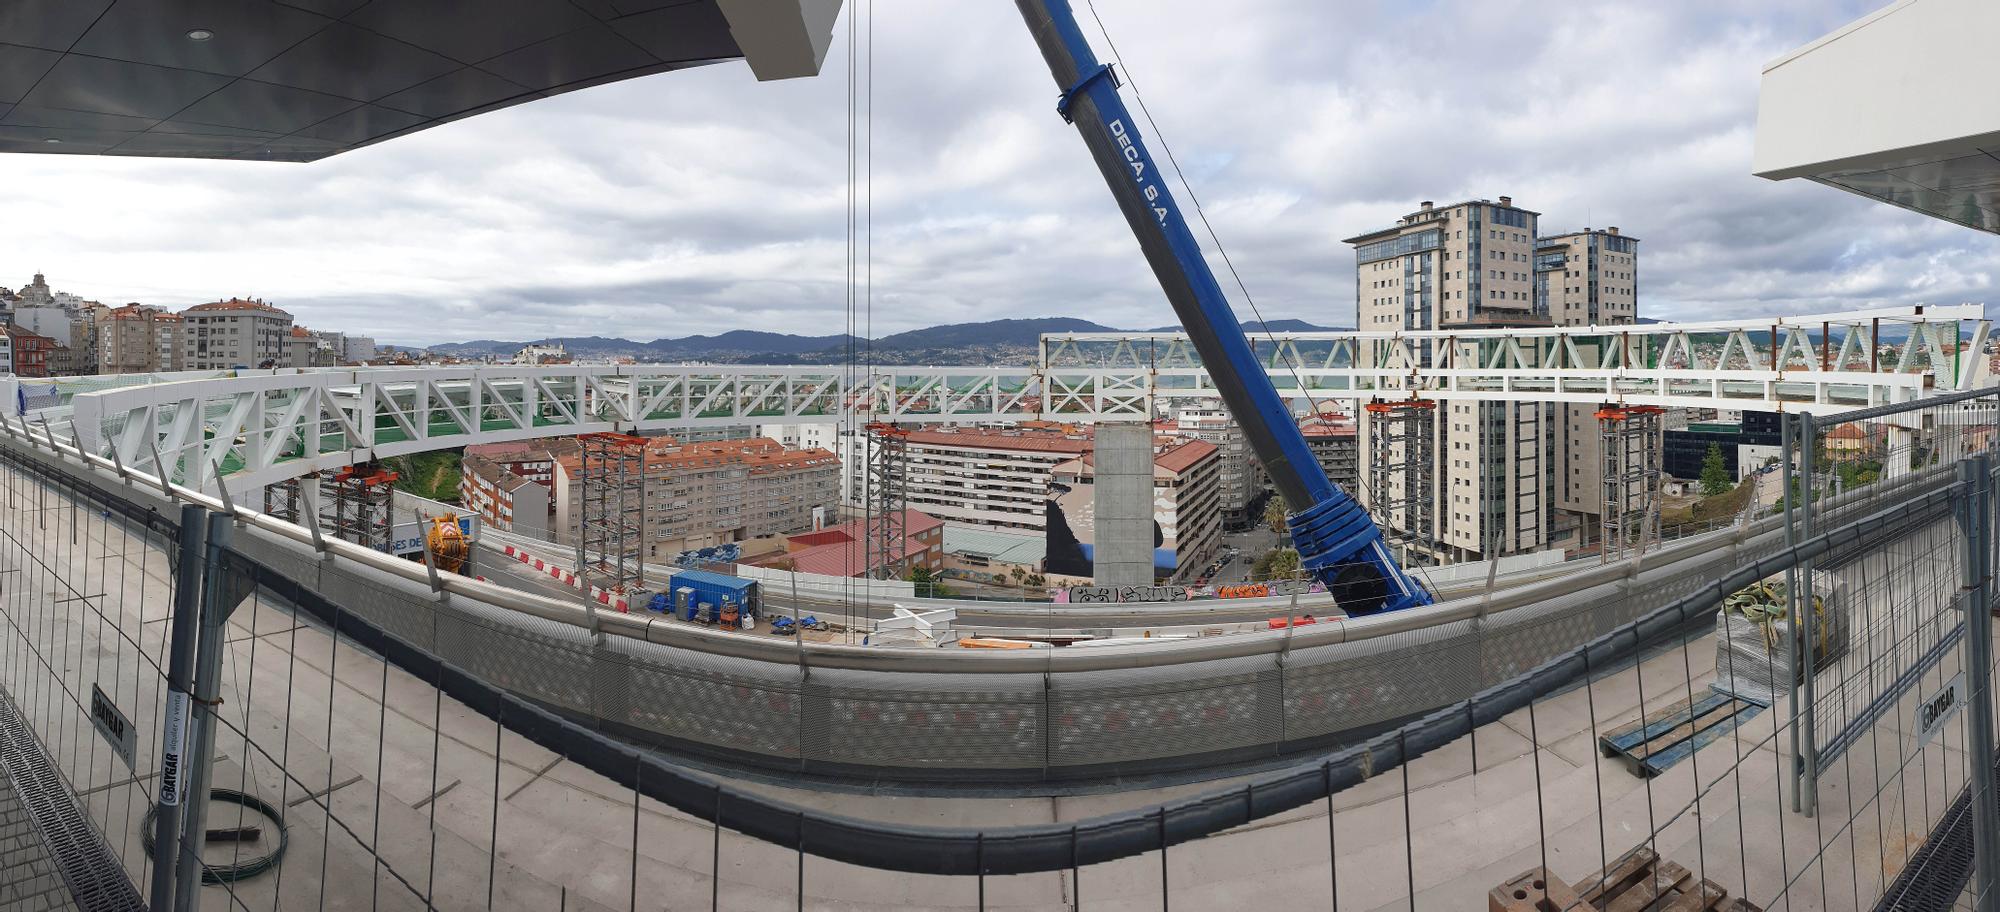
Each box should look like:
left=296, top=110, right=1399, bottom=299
left=1362, top=398, right=1438, bottom=562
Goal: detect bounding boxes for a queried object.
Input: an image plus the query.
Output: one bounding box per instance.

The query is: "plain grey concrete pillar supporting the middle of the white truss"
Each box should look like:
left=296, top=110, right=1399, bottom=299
left=1092, top=422, right=1152, bottom=586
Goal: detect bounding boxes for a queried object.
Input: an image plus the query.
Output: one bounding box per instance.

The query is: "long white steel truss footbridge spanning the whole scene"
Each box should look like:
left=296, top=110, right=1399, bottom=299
left=15, top=304, right=1990, bottom=490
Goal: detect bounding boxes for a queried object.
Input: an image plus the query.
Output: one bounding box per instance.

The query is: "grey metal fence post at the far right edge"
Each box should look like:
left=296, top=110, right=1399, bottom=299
left=1956, top=454, right=2000, bottom=912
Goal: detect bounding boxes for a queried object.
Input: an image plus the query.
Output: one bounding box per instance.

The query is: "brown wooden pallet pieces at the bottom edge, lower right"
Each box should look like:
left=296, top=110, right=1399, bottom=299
left=1486, top=846, right=1764, bottom=912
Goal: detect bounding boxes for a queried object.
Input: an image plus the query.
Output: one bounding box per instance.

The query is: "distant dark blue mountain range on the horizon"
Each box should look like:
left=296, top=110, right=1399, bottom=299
left=428, top=316, right=1336, bottom=364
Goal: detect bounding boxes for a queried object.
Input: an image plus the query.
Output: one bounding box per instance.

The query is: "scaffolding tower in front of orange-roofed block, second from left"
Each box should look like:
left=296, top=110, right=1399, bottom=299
left=576, top=434, right=646, bottom=592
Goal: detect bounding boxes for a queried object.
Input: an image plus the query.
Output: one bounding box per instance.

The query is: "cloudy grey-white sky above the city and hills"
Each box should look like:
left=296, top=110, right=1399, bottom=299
left=0, top=0, right=2000, bottom=344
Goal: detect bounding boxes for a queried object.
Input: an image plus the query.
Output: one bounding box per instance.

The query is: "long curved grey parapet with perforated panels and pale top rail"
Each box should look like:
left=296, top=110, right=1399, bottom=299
left=0, top=422, right=1950, bottom=784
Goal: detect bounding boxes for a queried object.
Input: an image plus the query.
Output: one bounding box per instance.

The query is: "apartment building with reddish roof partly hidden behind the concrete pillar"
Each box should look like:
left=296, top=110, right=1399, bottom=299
left=1050, top=436, right=1222, bottom=580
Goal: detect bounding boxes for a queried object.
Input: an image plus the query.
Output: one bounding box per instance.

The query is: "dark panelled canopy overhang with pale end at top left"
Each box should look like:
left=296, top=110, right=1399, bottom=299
left=0, top=0, right=840, bottom=162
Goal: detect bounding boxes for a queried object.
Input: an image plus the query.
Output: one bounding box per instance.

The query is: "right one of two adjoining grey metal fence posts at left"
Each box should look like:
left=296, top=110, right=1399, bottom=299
left=174, top=514, right=236, bottom=912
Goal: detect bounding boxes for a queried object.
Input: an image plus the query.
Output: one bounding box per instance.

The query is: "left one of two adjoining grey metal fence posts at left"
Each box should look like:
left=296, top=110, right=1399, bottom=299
left=148, top=504, right=208, bottom=910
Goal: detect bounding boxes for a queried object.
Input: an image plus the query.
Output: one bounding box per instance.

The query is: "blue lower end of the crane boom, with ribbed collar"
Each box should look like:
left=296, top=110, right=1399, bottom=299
left=1288, top=496, right=1432, bottom=616
